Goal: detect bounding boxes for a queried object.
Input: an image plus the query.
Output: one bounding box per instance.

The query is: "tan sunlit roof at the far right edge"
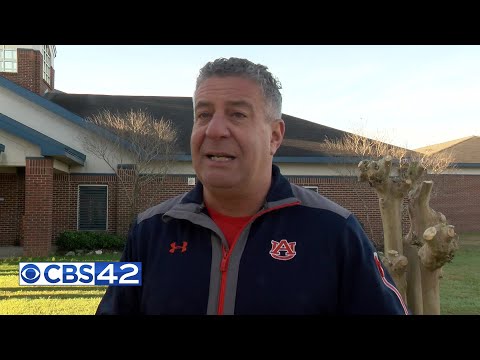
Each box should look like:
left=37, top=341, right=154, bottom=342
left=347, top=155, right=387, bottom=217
left=415, top=136, right=480, bottom=164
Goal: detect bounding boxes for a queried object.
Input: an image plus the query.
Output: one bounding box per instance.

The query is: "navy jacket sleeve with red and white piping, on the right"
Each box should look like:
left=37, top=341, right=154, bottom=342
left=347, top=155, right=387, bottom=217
left=340, top=215, right=409, bottom=315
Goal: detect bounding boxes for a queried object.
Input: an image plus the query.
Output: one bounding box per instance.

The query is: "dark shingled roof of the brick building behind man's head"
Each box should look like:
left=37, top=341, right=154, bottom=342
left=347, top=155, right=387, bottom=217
left=45, top=92, right=376, bottom=162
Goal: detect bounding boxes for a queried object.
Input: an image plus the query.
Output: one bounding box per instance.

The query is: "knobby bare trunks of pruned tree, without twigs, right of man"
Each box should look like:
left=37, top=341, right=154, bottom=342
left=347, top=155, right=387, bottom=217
left=358, top=155, right=458, bottom=315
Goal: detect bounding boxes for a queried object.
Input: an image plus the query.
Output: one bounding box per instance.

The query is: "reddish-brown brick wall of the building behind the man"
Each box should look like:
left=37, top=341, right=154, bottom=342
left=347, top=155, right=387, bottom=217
left=0, top=169, right=480, bottom=246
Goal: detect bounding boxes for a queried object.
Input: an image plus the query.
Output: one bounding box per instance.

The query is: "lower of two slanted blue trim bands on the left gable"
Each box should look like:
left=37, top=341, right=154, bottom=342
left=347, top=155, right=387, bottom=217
left=0, top=113, right=87, bottom=166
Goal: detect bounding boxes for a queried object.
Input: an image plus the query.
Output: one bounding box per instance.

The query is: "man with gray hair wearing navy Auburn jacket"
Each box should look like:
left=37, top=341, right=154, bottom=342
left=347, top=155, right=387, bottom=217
left=97, top=58, right=407, bottom=314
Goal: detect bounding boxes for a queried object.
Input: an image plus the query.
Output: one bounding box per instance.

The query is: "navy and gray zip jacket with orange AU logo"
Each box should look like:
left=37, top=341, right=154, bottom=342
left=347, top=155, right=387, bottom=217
left=97, top=165, right=408, bottom=315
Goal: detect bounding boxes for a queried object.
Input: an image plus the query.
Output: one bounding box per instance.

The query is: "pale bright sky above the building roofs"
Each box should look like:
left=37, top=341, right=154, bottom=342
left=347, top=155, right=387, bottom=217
left=54, top=45, right=480, bottom=149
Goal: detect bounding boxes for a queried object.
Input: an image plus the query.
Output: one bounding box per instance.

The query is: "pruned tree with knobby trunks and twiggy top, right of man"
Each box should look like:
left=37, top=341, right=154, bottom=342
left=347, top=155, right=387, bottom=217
left=326, top=133, right=458, bottom=315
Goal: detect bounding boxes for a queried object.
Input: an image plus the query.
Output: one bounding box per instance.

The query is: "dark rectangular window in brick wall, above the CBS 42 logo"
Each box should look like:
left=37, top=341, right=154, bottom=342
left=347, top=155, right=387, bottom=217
left=77, top=185, right=108, bottom=230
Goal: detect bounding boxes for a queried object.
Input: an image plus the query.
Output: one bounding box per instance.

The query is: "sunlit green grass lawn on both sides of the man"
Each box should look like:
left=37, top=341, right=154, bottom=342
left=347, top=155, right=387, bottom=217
left=0, top=233, right=480, bottom=315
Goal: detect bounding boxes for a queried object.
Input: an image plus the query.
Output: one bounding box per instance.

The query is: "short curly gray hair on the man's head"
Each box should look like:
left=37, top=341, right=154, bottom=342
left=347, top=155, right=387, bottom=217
left=194, top=57, right=282, bottom=119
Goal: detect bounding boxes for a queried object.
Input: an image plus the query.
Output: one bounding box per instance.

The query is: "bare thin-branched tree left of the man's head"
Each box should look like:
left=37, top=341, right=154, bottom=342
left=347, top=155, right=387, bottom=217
left=81, top=110, right=177, bottom=224
